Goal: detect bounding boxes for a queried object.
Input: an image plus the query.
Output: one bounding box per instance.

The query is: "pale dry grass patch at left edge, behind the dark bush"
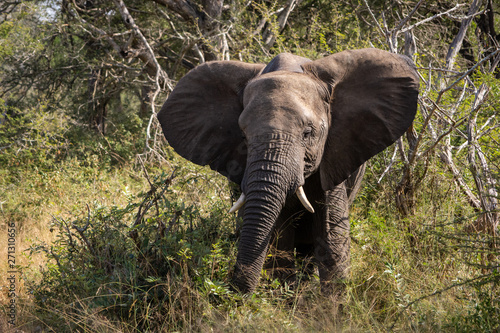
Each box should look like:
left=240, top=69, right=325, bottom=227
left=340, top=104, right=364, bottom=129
left=0, top=161, right=148, bottom=304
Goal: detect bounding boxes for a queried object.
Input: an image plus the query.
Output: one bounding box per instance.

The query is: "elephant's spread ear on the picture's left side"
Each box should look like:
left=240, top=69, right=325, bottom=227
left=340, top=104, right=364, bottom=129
left=157, top=61, right=264, bottom=184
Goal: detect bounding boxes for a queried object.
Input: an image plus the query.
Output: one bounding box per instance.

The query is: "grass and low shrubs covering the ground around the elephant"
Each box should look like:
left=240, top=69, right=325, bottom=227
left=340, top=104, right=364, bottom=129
left=0, top=102, right=500, bottom=332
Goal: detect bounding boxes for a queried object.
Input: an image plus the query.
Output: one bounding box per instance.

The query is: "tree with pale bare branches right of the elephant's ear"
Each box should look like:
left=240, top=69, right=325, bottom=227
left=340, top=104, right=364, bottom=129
left=365, top=0, right=500, bottom=239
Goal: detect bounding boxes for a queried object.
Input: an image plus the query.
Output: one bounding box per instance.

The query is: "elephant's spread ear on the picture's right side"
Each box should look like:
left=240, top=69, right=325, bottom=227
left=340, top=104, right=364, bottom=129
left=303, top=49, right=419, bottom=190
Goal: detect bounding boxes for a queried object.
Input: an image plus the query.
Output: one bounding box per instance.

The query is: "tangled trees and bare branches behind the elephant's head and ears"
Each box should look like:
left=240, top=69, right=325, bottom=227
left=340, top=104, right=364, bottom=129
left=0, top=0, right=500, bottom=229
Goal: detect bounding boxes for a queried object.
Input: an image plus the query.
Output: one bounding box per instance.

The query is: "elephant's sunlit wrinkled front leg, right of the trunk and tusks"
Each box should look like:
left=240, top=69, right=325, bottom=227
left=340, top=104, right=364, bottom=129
left=314, top=184, right=350, bottom=303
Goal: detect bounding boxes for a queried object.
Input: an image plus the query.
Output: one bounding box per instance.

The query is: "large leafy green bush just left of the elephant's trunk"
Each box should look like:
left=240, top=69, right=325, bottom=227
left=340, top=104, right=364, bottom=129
left=24, top=170, right=239, bottom=331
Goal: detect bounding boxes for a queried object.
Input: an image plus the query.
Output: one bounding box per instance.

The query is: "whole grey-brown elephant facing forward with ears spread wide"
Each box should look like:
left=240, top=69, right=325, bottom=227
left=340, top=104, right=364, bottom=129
left=158, top=49, right=418, bottom=293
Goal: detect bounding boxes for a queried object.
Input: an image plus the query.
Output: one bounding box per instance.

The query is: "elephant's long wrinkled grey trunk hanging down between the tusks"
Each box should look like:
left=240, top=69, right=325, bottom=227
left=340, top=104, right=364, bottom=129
left=233, top=134, right=303, bottom=293
